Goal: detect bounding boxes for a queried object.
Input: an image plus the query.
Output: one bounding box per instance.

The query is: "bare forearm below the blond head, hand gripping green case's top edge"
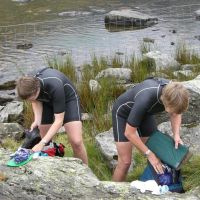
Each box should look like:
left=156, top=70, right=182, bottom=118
left=170, top=113, right=183, bottom=149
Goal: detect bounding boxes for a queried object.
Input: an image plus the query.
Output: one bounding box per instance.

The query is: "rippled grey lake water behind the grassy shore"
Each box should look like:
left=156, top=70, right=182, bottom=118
left=0, top=0, right=200, bottom=83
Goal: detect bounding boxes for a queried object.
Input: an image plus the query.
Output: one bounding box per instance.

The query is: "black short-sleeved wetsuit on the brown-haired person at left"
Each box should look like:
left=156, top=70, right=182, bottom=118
left=35, top=68, right=81, bottom=124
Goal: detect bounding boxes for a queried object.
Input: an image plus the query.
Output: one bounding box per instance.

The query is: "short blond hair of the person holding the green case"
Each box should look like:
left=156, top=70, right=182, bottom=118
left=161, top=82, right=189, bottom=114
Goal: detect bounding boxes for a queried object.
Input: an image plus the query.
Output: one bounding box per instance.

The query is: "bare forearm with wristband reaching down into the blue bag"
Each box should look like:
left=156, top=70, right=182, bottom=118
left=125, top=124, right=164, bottom=173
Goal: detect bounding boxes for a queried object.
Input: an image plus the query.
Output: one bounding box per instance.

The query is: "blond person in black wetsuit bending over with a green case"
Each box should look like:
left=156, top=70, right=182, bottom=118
left=112, top=78, right=189, bottom=181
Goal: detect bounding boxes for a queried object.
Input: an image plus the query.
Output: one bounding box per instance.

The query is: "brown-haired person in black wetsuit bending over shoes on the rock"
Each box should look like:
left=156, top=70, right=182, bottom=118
left=16, top=68, right=88, bottom=164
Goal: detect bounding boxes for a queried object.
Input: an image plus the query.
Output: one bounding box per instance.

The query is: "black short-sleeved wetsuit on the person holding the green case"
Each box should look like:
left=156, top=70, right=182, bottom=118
left=112, top=78, right=169, bottom=142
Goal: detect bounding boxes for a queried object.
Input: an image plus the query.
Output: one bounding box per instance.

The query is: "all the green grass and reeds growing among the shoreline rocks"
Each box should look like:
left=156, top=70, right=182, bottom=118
left=3, top=43, right=200, bottom=191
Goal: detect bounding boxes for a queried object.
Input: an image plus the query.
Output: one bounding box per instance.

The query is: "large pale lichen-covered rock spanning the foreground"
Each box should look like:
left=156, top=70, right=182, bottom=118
left=0, top=149, right=200, bottom=200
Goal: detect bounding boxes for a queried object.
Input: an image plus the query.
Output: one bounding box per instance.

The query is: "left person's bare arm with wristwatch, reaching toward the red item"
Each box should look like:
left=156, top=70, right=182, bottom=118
left=32, top=112, right=64, bottom=152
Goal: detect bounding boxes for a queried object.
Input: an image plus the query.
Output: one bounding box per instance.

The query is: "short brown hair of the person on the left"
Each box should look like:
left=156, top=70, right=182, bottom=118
left=16, top=76, right=40, bottom=99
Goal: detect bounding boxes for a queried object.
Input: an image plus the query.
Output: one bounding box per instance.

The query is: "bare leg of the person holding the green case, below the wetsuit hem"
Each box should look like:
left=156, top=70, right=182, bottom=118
left=112, top=142, right=133, bottom=182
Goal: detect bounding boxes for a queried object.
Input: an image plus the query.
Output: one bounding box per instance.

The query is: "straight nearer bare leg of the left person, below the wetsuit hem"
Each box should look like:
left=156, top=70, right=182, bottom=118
left=64, top=121, right=88, bottom=164
